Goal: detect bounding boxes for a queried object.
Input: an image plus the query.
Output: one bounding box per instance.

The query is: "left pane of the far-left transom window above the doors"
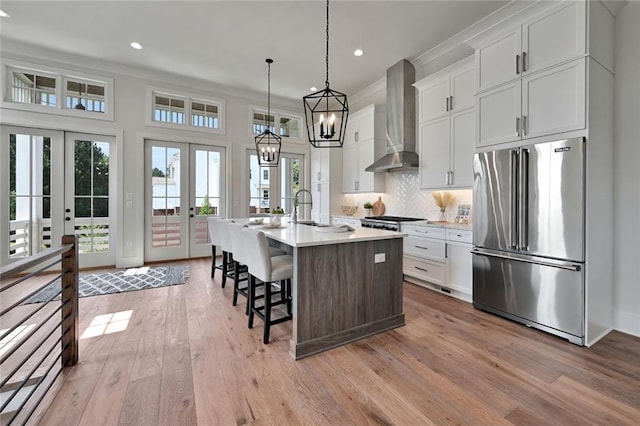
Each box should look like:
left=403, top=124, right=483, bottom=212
left=11, top=70, right=56, bottom=108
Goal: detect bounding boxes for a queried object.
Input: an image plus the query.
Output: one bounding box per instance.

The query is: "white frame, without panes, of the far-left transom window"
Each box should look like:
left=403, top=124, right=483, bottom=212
left=0, top=58, right=114, bottom=121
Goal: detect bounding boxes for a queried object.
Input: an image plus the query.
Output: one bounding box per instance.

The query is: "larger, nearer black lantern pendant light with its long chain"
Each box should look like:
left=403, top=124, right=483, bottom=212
left=302, top=0, right=349, bottom=148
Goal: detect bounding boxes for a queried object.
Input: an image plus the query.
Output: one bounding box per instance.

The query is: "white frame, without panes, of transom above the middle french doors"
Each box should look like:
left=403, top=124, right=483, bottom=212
left=145, top=86, right=226, bottom=135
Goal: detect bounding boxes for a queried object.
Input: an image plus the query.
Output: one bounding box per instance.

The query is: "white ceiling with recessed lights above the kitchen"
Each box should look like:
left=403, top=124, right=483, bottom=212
left=0, top=0, right=508, bottom=99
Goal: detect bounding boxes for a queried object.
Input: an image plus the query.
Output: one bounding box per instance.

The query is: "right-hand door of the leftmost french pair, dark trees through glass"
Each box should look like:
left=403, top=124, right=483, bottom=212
left=64, top=133, right=117, bottom=267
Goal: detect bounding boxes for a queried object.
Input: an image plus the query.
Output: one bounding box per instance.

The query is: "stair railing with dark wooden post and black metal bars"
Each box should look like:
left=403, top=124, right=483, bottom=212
left=0, top=235, right=79, bottom=425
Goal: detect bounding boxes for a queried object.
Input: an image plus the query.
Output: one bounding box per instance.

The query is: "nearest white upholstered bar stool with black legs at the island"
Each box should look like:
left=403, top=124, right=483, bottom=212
left=241, top=229, right=293, bottom=344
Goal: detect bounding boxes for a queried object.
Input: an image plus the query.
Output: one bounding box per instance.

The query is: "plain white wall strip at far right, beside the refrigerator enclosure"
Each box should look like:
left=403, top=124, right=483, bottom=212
left=613, top=1, right=640, bottom=336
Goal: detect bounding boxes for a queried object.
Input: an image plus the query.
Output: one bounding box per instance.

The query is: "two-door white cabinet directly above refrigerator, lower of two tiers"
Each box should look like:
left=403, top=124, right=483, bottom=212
left=477, top=58, right=586, bottom=146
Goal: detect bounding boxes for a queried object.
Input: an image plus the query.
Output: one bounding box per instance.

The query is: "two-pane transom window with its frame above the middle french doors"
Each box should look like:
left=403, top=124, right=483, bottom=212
left=146, top=87, right=224, bottom=133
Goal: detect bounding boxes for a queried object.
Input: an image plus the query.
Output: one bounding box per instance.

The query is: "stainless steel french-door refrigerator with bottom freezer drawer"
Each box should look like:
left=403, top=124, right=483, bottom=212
left=472, top=138, right=586, bottom=345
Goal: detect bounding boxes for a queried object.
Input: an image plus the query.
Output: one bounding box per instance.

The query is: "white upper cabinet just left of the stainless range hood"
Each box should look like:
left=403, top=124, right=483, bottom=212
left=342, top=105, right=385, bottom=193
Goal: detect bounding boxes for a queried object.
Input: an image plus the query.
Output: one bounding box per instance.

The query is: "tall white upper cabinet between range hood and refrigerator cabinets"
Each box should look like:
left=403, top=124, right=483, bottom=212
left=414, top=57, right=475, bottom=189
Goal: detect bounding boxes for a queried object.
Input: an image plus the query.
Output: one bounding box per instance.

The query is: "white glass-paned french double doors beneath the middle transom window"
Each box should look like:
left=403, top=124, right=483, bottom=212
left=145, top=140, right=226, bottom=261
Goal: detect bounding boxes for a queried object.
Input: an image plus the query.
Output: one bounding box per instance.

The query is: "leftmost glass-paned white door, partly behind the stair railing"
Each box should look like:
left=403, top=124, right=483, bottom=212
left=0, top=126, right=64, bottom=265
